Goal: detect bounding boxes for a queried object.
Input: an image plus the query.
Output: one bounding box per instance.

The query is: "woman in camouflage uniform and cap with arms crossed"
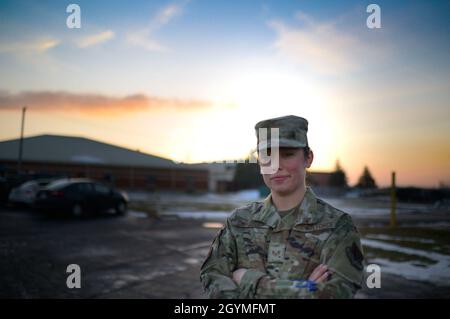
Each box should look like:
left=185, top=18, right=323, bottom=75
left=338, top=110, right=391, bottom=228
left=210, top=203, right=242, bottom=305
left=200, top=115, right=364, bottom=298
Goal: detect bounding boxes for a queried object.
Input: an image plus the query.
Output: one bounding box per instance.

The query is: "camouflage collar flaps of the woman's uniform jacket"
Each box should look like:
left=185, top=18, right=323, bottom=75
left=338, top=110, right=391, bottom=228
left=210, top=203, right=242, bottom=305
left=253, top=187, right=323, bottom=228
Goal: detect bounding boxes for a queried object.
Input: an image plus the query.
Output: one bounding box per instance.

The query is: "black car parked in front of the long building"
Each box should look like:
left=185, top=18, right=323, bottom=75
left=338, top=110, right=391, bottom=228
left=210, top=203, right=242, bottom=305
left=34, top=179, right=128, bottom=217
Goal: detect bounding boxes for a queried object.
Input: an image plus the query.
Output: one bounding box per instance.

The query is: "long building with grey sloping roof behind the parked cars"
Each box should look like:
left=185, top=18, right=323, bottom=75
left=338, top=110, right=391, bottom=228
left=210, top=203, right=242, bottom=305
left=0, top=135, right=209, bottom=192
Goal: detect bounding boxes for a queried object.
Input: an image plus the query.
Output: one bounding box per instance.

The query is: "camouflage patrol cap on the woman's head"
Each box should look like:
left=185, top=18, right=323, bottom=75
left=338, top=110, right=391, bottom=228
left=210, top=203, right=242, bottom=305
left=255, top=115, right=308, bottom=151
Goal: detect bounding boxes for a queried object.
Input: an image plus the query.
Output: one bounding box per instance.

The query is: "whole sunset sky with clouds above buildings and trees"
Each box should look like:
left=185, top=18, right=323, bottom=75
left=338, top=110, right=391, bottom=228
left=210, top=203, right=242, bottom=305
left=0, top=0, right=450, bottom=187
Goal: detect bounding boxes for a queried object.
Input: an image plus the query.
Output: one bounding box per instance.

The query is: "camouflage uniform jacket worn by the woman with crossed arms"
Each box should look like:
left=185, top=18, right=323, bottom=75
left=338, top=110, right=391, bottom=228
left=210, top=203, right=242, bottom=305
left=200, top=187, right=364, bottom=298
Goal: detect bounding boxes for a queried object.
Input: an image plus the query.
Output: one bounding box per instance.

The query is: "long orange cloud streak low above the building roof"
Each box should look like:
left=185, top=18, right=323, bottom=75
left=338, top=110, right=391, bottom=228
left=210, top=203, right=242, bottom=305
left=0, top=90, right=212, bottom=116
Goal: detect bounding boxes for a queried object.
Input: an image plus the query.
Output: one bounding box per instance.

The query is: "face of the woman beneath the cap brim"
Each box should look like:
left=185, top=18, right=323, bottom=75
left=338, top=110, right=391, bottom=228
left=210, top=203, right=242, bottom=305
left=263, top=147, right=314, bottom=195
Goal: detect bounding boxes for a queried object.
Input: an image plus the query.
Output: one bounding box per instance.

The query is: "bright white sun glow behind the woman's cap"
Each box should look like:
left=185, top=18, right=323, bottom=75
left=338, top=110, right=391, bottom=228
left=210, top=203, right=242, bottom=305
left=214, top=71, right=339, bottom=170
